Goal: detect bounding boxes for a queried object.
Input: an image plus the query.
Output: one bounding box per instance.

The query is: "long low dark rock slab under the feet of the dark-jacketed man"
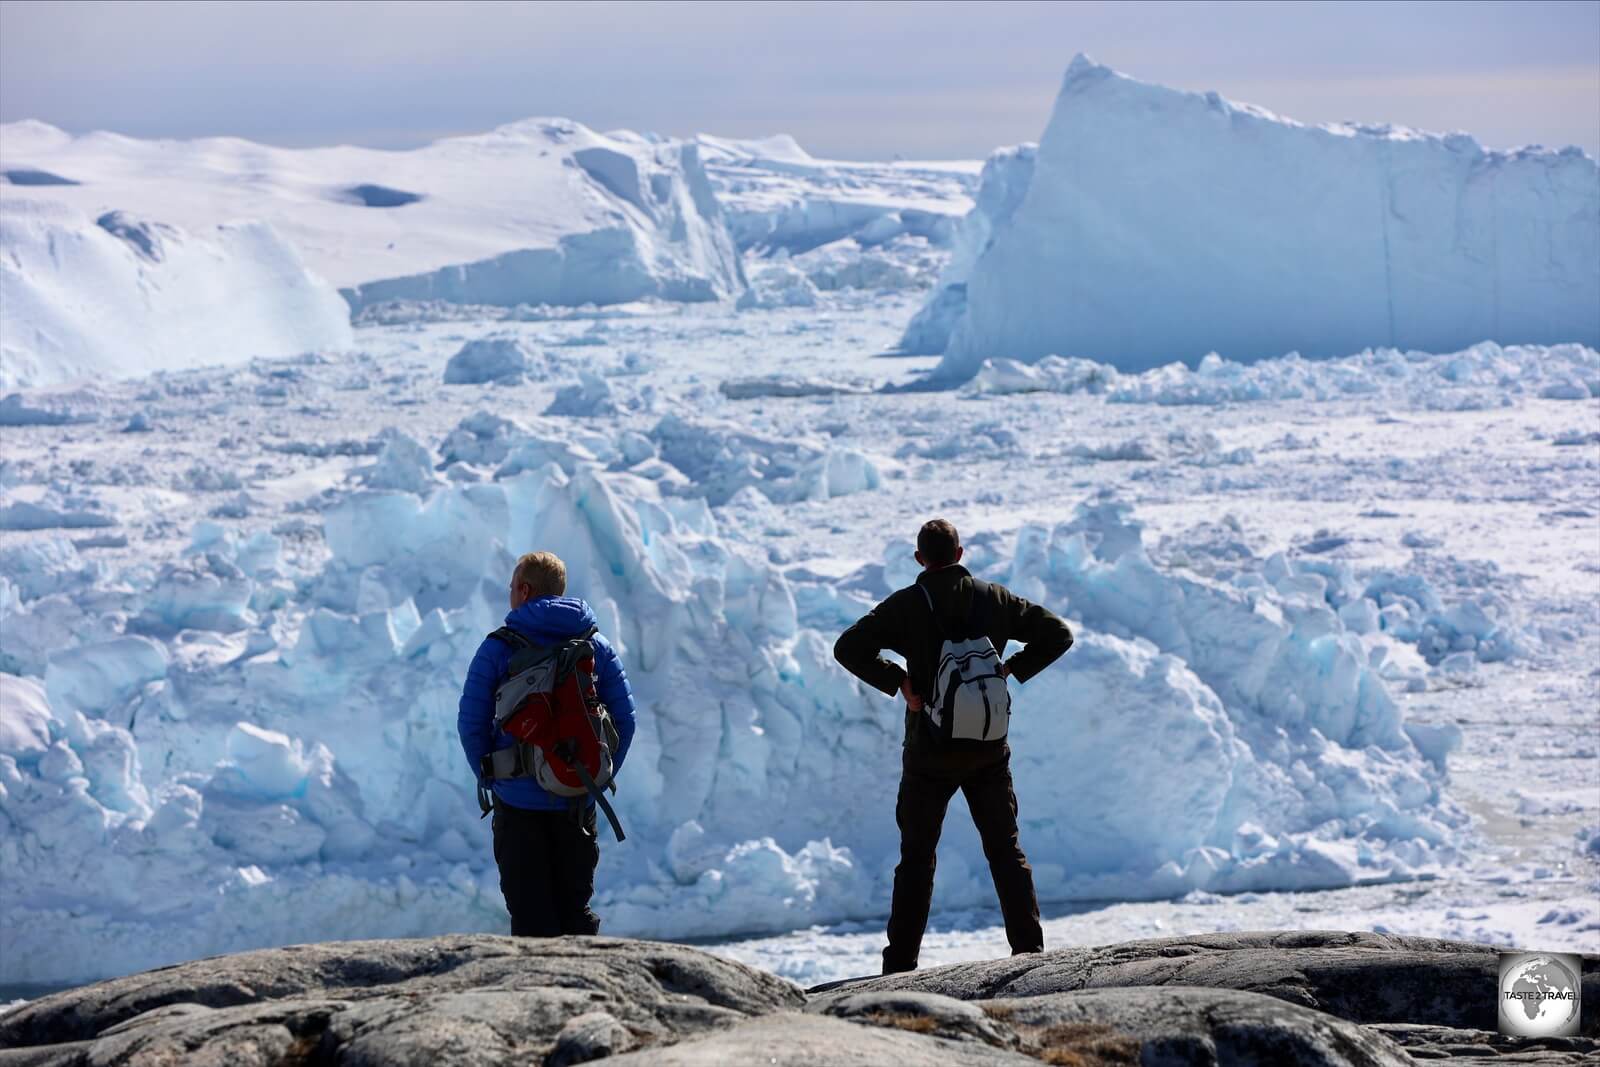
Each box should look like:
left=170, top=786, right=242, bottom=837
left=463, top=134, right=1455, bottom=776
left=813, top=931, right=1600, bottom=1035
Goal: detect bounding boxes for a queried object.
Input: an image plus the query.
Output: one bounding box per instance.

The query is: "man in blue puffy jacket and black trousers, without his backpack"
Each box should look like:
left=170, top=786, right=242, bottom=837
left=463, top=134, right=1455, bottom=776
left=456, top=552, right=634, bottom=937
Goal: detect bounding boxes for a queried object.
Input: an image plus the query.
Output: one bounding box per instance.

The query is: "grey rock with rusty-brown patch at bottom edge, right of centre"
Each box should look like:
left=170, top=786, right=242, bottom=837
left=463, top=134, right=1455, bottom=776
left=981, top=987, right=1411, bottom=1067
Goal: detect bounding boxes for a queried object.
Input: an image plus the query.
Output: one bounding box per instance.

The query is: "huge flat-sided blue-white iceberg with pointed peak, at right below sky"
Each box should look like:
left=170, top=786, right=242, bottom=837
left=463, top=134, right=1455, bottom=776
left=928, top=56, right=1600, bottom=379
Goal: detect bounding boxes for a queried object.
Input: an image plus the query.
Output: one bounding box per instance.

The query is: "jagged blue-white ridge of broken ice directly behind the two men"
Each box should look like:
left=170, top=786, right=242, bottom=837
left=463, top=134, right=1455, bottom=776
left=0, top=403, right=1486, bottom=981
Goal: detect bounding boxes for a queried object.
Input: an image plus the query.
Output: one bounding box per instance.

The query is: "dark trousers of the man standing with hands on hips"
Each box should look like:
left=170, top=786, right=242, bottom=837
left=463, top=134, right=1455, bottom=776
left=883, top=744, right=1045, bottom=974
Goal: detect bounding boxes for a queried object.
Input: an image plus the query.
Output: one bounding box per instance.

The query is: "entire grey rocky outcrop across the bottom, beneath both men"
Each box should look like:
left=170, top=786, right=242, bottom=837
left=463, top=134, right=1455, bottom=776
left=0, top=933, right=1600, bottom=1067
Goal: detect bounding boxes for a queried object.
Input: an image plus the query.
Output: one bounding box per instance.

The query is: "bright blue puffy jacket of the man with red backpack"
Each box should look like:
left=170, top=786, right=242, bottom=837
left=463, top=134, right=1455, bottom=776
left=456, top=597, right=634, bottom=811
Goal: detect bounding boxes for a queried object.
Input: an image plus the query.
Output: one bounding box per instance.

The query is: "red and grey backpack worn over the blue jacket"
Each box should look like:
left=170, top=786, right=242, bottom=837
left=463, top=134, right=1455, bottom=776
left=478, top=625, right=624, bottom=841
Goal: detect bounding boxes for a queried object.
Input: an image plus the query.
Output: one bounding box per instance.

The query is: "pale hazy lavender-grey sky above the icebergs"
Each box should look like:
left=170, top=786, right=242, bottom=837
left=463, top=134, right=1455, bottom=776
left=0, top=0, right=1600, bottom=158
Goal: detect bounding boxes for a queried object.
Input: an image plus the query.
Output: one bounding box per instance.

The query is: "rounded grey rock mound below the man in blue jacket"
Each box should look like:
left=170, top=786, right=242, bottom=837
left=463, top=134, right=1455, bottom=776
left=0, top=936, right=805, bottom=1067
